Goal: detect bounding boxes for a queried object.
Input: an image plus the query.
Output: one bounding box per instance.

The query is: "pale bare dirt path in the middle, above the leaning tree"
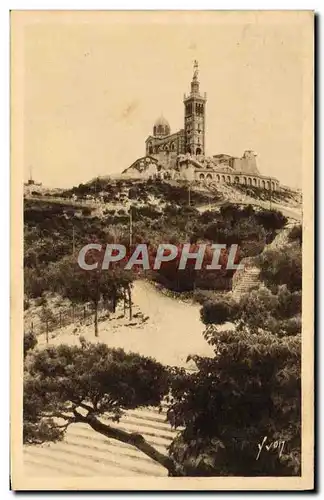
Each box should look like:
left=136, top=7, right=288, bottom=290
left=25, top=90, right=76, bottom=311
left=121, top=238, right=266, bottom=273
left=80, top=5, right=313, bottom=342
left=39, top=281, right=213, bottom=367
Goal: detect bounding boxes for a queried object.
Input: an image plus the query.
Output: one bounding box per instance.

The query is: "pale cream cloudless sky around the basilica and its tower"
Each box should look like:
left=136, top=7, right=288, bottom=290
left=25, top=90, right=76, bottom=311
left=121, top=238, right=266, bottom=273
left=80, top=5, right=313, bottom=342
left=22, top=12, right=305, bottom=187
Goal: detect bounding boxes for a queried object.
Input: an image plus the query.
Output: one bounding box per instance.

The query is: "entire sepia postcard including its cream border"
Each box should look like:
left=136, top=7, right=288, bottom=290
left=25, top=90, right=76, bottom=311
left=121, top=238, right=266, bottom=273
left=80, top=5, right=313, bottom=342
left=11, top=11, right=314, bottom=491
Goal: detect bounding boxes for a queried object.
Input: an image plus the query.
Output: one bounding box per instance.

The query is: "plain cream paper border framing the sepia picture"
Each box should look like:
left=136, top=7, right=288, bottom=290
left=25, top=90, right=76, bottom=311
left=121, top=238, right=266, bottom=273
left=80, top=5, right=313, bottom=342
left=10, top=10, right=314, bottom=491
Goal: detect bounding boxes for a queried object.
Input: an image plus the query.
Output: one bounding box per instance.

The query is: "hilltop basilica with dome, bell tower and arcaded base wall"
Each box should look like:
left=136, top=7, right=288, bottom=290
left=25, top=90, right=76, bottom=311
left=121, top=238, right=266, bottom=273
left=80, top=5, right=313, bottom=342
left=123, top=61, right=279, bottom=191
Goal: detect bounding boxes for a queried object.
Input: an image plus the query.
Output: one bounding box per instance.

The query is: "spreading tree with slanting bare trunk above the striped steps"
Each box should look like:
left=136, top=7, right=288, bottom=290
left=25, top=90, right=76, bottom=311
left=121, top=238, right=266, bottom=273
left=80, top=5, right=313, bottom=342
left=24, top=339, right=180, bottom=475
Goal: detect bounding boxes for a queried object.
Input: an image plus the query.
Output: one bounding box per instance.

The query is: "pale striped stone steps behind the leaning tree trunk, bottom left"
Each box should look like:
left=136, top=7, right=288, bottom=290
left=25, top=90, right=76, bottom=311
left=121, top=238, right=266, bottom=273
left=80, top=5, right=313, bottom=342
left=24, top=406, right=177, bottom=477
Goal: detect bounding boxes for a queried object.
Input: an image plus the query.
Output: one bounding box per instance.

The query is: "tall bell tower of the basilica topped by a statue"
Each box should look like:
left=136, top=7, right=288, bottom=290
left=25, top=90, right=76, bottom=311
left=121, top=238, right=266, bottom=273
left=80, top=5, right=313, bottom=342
left=183, top=61, right=207, bottom=155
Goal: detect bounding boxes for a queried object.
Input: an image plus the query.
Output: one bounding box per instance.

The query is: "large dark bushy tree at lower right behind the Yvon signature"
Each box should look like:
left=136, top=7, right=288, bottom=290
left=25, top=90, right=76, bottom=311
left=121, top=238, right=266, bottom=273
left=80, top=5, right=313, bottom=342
left=169, top=325, right=301, bottom=476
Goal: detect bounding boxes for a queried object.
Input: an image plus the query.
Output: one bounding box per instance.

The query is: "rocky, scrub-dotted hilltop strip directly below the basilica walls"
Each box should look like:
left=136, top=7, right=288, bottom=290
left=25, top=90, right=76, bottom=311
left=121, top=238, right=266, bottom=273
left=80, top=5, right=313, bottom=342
left=26, top=177, right=301, bottom=215
